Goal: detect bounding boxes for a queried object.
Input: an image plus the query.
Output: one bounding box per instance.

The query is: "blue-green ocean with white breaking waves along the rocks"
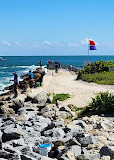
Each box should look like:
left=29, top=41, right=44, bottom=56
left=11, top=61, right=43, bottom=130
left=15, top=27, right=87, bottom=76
left=0, top=56, right=114, bottom=94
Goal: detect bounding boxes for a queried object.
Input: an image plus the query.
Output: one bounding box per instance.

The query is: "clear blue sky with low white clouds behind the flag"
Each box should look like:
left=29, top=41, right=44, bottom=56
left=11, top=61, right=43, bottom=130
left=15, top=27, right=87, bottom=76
left=0, top=0, right=114, bottom=56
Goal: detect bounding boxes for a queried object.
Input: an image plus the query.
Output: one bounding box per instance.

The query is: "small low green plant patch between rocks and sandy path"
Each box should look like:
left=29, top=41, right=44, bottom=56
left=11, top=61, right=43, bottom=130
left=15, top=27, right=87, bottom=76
left=52, top=93, right=70, bottom=103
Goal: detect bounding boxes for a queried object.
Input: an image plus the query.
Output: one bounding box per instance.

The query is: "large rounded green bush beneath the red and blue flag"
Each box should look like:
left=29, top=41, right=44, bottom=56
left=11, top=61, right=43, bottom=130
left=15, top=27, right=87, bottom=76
left=77, top=61, right=114, bottom=85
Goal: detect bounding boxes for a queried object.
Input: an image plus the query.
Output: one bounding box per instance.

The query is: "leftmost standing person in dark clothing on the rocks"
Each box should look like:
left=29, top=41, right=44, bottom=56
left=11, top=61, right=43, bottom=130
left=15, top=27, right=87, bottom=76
left=10, top=72, right=19, bottom=97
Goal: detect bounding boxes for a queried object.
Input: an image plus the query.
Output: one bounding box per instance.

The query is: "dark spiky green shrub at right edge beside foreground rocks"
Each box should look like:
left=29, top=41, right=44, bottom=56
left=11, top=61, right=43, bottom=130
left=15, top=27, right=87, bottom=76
left=78, top=92, right=114, bottom=117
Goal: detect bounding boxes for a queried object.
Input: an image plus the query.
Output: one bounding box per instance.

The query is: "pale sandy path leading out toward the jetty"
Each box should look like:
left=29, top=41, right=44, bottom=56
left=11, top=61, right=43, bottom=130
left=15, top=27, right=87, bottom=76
left=23, top=70, right=114, bottom=107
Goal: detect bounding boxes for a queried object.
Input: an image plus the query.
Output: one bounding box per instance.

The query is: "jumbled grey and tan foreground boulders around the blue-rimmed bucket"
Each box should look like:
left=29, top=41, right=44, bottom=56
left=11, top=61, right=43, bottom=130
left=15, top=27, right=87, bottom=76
left=0, top=92, right=114, bottom=160
